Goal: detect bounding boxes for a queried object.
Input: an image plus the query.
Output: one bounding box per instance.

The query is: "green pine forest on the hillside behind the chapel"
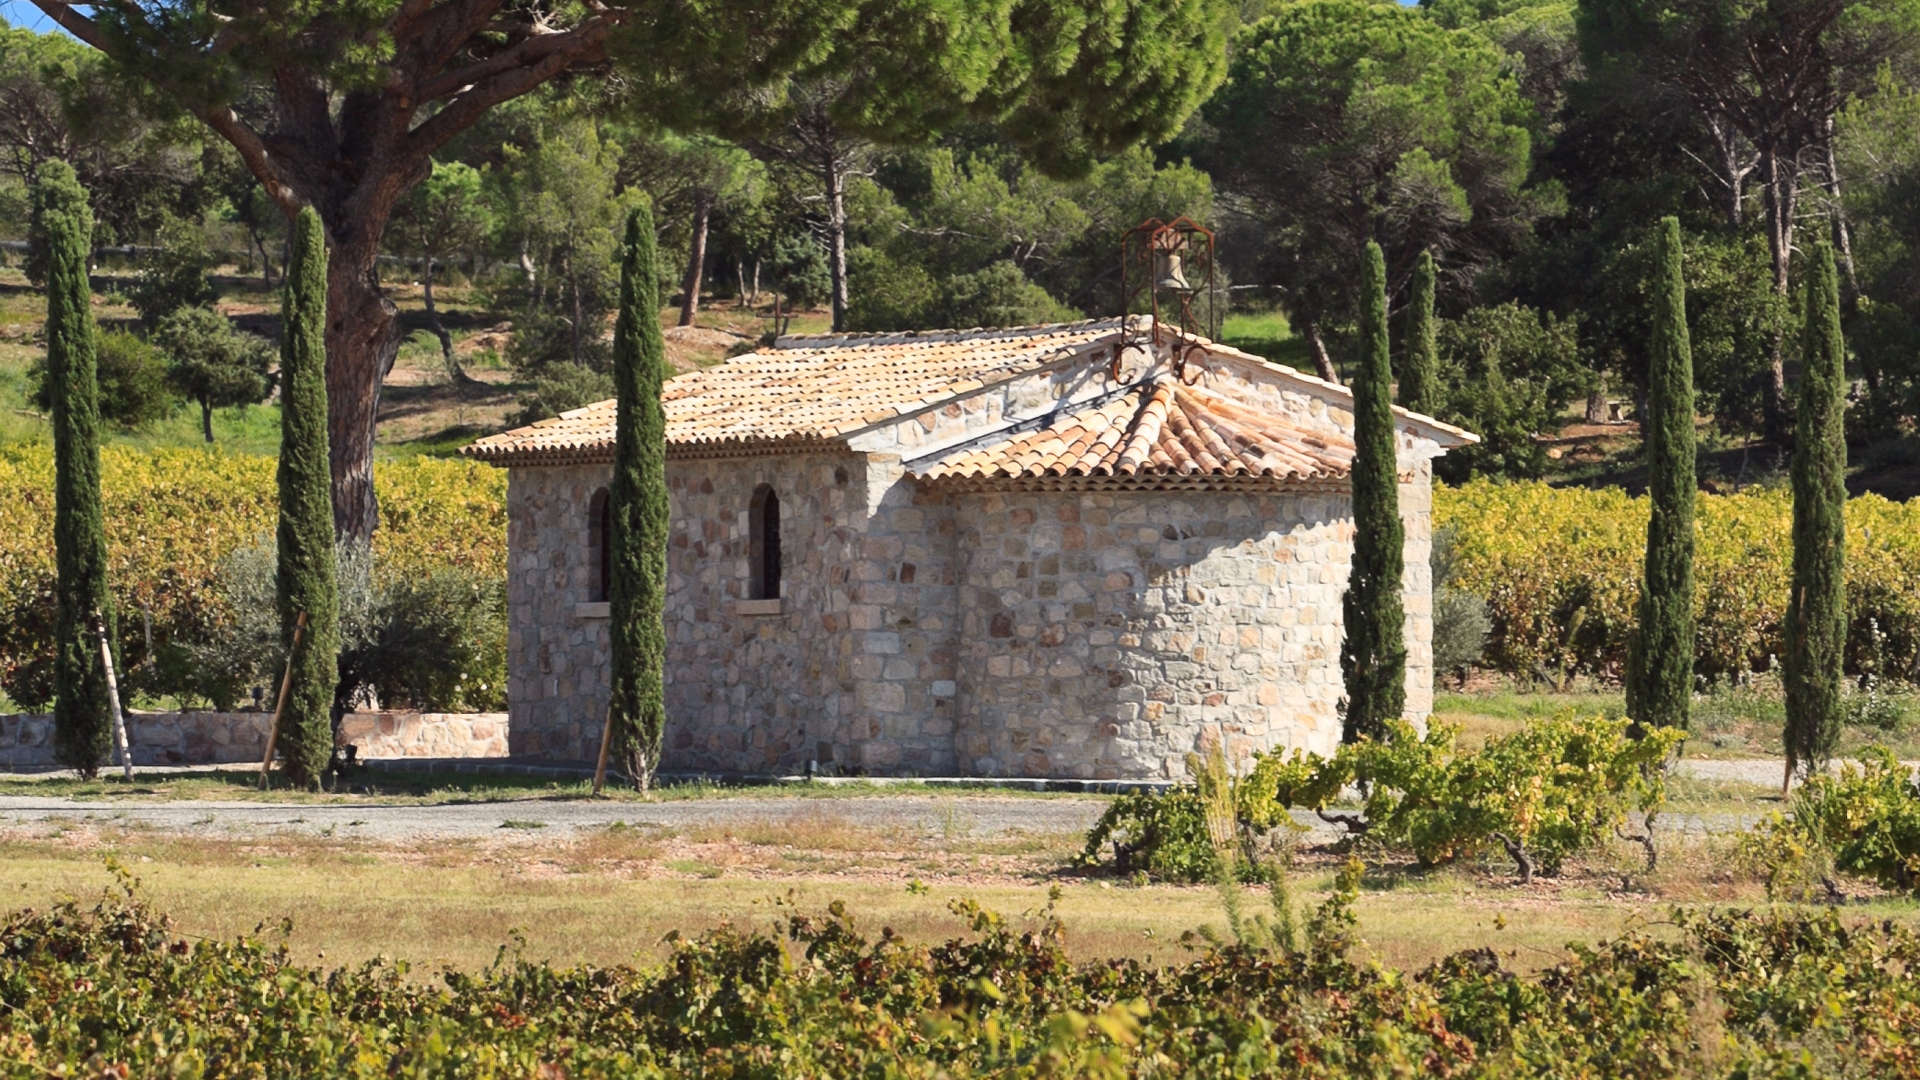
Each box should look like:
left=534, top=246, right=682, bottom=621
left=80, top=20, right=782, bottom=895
left=0, top=0, right=1920, bottom=490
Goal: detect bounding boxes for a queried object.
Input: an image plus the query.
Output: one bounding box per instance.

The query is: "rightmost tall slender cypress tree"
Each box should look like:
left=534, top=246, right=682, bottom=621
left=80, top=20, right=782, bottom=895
left=1786, top=244, right=1847, bottom=782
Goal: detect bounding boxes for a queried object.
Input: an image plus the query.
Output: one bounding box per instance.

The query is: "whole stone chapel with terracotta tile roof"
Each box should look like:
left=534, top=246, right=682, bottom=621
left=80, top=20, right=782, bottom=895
left=467, top=317, right=1475, bottom=780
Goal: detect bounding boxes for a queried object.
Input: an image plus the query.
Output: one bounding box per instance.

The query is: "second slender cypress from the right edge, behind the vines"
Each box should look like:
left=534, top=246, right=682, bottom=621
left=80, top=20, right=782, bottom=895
left=1626, top=217, right=1695, bottom=730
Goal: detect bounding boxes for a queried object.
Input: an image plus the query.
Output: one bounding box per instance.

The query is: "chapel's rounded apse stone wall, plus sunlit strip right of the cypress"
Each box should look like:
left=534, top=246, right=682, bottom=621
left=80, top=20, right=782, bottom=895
left=954, top=475, right=1432, bottom=778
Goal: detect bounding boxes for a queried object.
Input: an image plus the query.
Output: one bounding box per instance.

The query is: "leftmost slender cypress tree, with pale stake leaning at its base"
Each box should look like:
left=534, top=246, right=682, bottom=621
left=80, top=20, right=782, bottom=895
left=33, top=161, right=113, bottom=778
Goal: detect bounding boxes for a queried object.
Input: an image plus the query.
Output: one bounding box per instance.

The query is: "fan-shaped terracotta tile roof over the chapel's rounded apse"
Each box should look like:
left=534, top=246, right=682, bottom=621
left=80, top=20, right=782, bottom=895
left=920, top=379, right=1354, bottom=480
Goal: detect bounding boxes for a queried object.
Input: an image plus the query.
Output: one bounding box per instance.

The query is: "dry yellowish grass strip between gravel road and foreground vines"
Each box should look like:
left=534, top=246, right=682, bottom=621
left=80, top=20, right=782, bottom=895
left=0, top=809, right=1920, bottom=974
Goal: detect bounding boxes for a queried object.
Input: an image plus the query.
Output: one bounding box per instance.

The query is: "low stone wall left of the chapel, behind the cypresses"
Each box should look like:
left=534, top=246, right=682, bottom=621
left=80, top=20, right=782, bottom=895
left=0, top=711, right=507, bottom=773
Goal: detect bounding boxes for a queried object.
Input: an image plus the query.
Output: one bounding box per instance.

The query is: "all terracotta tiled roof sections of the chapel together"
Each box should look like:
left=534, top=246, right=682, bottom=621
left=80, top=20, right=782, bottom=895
left=461, top=317, right=1476, bottom=472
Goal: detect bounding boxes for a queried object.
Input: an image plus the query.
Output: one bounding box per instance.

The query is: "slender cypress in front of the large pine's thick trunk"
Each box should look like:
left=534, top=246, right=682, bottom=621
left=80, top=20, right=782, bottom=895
left=275, top=208, right=340, bottom=788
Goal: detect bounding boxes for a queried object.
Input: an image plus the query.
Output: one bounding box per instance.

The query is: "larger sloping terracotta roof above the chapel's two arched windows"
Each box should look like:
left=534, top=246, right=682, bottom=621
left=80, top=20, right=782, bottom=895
left=463, top=319, right=1119, bottom=457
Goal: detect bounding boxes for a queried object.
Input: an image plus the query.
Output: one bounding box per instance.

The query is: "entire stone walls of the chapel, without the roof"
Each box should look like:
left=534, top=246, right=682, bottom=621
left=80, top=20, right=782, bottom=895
left=509, top=430, right=1432, bottom=778
